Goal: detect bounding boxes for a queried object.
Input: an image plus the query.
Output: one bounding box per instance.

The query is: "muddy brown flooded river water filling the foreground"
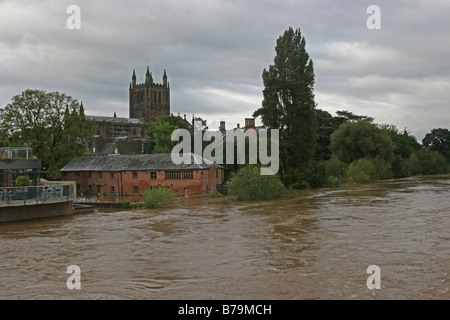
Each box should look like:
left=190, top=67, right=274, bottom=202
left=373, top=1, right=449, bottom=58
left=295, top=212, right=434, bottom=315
left=0, top=175, right=450, bottom=299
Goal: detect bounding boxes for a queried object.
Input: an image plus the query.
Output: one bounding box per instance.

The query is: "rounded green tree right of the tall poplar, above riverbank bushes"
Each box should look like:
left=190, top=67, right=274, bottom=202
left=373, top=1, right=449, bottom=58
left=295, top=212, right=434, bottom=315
left=330, top=120, right=394, bottom=164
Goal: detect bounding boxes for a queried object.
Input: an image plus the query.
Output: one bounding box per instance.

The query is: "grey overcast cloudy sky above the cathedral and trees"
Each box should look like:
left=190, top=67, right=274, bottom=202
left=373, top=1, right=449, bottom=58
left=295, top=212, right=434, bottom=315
left=0, top=0, right=450, bottom=141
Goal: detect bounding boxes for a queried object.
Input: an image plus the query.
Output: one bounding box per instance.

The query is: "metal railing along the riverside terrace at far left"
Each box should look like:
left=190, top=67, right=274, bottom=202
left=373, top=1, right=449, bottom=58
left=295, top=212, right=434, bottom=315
left=0, top=183, right=75, bottom=201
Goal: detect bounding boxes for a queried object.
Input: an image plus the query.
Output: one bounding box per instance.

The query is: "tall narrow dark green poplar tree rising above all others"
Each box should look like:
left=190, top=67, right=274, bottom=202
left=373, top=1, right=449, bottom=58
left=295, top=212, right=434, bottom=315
left=253, top=28, right=316, bottom=180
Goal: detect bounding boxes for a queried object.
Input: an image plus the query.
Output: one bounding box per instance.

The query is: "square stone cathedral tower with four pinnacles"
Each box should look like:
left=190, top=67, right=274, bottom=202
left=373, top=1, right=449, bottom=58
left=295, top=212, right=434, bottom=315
left=130, top=67, right=170, bottom=122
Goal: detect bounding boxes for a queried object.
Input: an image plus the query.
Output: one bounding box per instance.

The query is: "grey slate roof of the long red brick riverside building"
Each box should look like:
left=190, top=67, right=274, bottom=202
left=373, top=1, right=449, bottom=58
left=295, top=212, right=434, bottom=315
left=60, top=153, right=222, bottom=172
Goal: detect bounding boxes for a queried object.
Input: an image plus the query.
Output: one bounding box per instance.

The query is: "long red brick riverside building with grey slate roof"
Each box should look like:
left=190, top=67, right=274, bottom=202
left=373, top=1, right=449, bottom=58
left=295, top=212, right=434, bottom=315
left=61, top=154, right=224, bottom=197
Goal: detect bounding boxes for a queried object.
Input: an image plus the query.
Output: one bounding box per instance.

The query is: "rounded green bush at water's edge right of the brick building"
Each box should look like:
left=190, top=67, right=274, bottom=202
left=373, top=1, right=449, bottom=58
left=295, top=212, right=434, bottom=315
left=227, top=165, right=287, bottom=200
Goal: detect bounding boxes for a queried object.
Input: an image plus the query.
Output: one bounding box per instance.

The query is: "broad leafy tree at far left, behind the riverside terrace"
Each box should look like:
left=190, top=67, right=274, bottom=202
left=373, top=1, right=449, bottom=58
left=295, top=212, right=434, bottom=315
left=0, top=89, right=95, bottom=176
